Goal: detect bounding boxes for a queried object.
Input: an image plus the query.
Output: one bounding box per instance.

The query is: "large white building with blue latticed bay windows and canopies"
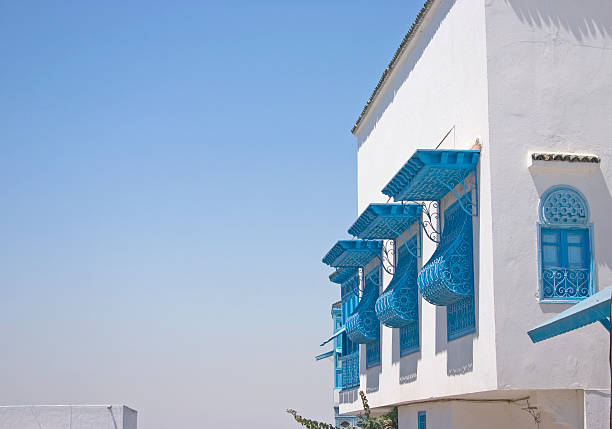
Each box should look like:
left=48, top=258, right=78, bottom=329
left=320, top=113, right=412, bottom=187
left=324, top=0, right=612, bottom=429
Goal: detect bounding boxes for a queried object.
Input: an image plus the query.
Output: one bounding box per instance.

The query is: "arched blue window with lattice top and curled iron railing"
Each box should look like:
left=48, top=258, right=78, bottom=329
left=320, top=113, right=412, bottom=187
left=538, top=186, right=594, bottom=302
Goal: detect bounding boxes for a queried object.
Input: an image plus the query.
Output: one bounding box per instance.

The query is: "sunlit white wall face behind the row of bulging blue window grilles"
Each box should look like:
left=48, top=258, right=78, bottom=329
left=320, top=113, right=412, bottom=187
left=341, top=0, right=496, bottom=412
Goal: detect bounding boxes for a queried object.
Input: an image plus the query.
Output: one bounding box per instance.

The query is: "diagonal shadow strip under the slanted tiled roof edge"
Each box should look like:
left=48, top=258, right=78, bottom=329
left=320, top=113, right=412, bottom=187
left=358, top=0, right=456, bottom=148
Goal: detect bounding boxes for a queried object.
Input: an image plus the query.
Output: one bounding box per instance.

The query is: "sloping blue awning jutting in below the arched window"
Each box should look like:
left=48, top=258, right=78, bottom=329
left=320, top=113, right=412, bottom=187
left=527, top=286, right=612, bottom=343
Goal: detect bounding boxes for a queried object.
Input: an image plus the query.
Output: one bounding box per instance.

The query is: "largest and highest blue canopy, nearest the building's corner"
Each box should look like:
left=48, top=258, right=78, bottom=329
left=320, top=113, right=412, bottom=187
left=382, top=149, right=480, bottom=201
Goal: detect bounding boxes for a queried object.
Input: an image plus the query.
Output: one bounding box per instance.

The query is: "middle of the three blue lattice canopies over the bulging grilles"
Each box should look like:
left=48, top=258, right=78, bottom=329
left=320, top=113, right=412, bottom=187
left=348, top=203, right=422, bottom=240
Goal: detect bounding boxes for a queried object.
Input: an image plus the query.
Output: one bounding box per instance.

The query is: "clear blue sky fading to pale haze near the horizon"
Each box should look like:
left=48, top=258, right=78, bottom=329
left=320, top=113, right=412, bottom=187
left=0, top=0, right=422, bottom=429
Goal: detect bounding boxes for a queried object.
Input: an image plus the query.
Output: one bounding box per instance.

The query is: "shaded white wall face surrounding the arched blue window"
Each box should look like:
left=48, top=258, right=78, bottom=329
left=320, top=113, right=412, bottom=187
left=486, top=0, right=612, bottom=389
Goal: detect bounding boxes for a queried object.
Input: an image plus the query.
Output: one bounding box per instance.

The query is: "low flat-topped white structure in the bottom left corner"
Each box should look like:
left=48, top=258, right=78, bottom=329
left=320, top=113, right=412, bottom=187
left=0, top=405, right=137, bottom=429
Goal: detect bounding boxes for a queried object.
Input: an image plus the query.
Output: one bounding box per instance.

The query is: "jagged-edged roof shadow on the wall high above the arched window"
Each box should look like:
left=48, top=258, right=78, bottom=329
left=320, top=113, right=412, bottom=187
left=506, top=0, right=612, bottom=41
